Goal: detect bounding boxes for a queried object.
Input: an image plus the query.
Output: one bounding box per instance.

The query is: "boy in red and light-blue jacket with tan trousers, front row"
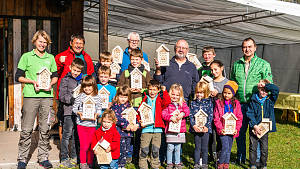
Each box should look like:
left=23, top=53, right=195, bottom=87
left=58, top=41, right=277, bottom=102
left=139, top=80, right=171, bottom=169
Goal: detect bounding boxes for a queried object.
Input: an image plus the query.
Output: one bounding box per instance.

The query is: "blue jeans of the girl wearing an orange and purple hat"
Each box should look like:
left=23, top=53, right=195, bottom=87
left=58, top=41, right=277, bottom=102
left=219, top=135, right=233, bottom=164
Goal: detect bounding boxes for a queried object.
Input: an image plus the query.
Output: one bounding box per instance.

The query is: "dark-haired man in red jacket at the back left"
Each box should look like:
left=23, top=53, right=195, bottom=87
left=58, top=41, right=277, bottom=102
left=55, top=35, right=94, bottom=140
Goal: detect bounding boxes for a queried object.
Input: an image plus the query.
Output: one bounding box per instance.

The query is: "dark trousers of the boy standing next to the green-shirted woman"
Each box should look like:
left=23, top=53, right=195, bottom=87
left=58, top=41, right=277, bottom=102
left=60, top=115, right=78, bottom=161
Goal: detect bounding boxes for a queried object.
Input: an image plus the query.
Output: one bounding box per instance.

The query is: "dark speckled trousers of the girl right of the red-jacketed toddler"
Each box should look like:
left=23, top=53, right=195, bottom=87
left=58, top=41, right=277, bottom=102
left=118, top=137, right=131, bottom=167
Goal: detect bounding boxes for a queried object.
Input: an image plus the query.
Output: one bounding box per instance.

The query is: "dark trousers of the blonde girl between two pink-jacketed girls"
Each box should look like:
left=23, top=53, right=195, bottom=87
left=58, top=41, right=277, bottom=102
left=194, top=133, right=209, bottom=164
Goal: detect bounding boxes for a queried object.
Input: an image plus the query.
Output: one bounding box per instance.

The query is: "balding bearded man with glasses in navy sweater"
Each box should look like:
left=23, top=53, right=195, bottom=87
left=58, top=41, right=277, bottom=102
left=154, top=39, right=199, bottom=101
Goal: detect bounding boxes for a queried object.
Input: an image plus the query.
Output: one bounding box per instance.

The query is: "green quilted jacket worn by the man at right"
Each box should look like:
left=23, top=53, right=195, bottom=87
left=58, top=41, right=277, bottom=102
left=230, top=53, right=273, bottom=103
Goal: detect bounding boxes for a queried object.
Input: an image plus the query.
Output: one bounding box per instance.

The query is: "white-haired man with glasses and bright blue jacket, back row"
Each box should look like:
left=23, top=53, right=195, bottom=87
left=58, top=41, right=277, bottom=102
left=121, top=32, right=148, bottom=72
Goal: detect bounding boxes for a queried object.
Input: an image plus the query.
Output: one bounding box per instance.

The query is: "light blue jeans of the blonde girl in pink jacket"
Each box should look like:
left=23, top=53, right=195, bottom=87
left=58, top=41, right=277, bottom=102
left=167, top=143, right=181, bottom=164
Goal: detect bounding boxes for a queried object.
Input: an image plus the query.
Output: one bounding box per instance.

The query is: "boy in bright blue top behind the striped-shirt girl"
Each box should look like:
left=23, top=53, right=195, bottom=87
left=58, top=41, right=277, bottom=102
left=97, top=66, right=117, bottom=108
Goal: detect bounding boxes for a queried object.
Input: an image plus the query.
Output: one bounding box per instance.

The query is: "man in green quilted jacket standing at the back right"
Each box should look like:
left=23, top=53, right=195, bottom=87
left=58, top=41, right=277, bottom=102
left=230, top=37, right=272, bottom=163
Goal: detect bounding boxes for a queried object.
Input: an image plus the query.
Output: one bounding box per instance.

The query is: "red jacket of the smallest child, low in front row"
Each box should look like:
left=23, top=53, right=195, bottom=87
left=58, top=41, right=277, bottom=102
left=91, top=124, right=121, bottom=160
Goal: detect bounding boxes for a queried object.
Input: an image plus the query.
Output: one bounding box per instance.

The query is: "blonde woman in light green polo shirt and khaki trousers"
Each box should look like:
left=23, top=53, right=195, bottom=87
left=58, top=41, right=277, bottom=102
left=15, top=30, right=57, bottom=169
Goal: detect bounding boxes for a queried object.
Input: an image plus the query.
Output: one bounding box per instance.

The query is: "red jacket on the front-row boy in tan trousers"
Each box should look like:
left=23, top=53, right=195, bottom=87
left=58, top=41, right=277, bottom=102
left=138, top=91, right=171, bottom=128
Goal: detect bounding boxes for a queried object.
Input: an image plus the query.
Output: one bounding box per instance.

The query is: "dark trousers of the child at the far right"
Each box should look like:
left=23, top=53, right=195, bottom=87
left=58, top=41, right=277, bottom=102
left=249, top=131, right=269, bottom=167
